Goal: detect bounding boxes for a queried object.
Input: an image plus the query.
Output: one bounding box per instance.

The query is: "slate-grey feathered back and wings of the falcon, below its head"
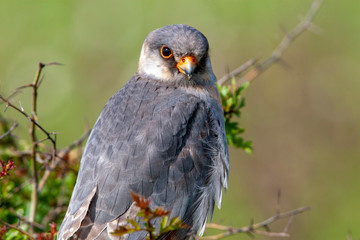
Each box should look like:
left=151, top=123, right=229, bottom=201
left=59, top=75, right=228, bottom=239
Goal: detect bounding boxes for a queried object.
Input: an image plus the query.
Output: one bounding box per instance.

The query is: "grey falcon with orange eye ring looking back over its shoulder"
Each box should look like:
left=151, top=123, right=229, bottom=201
left=58, top=24, right=229, bottom=240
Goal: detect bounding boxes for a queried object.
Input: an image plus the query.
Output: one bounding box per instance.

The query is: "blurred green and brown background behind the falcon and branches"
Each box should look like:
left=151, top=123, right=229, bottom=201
left=0, top=0, right=360, bottom=239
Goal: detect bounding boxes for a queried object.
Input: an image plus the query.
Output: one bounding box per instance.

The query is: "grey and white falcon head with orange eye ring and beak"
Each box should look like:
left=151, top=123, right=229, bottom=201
left=138, top=24, right=215, bottom=85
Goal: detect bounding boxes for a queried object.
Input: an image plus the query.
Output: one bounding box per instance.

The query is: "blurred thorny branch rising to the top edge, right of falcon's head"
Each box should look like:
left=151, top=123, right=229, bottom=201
left=218, top=0, right=323, bottom=86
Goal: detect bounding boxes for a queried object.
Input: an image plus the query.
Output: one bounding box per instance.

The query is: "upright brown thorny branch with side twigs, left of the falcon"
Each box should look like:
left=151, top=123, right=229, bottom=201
left=0, top=60, right=90, bottom=234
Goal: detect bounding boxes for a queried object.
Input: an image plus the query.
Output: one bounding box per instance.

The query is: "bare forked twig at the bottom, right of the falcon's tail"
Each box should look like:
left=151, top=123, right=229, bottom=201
left=199, top=207, right=310, bottom=240
